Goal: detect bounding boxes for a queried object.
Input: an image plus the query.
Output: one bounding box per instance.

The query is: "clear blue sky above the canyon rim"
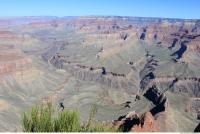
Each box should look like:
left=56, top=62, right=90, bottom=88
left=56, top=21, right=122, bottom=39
left=0, top=0, right=200, bottom=19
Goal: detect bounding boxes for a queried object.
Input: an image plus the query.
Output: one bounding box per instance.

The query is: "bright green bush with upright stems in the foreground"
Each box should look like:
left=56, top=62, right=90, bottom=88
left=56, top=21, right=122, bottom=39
left=22, top=103, right=117, bottom=132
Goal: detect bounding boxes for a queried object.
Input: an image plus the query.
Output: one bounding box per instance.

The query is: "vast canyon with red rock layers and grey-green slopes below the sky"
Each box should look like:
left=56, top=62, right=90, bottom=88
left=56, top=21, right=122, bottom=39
left=0, top=16, right=200, bottom=132
